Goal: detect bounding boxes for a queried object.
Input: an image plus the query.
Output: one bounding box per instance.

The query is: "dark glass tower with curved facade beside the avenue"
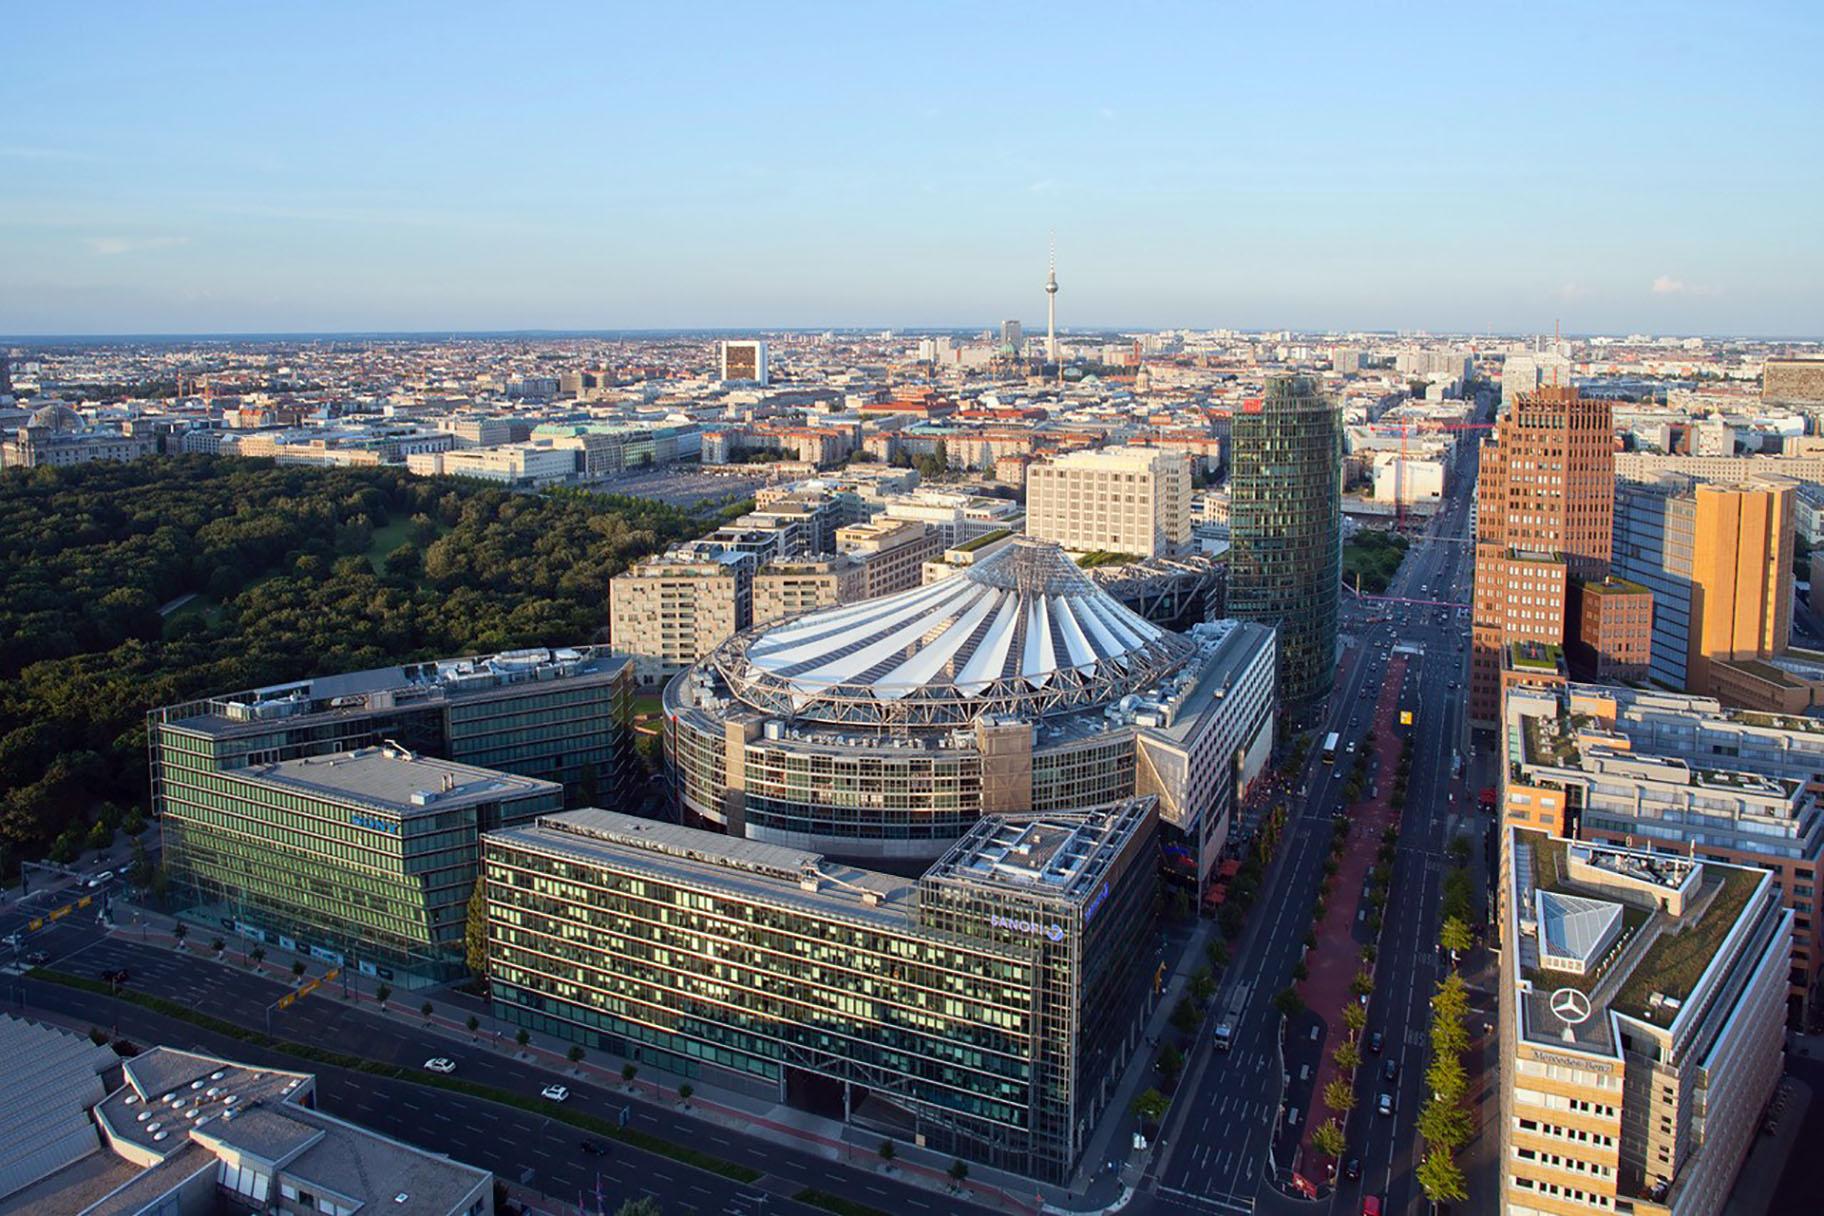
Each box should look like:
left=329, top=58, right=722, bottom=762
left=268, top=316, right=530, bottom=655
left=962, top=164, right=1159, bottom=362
left=1229, top=376, right=1342, bottom=716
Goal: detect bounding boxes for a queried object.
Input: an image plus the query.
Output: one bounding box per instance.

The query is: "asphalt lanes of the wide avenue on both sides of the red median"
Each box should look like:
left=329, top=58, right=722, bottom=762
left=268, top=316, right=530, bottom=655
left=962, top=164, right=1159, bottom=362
left=1133, top=408, right=1481, bottom=1216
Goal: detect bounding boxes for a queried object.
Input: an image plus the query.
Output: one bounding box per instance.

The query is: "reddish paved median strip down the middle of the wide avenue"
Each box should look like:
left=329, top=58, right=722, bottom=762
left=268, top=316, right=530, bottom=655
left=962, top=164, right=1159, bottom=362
left=1290, top=654, right=1406, bottom=1185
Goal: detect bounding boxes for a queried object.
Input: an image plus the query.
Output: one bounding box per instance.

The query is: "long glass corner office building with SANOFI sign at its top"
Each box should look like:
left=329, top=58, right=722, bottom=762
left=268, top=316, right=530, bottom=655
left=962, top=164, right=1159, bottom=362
left=483, top=799, right=1158, bottom=1181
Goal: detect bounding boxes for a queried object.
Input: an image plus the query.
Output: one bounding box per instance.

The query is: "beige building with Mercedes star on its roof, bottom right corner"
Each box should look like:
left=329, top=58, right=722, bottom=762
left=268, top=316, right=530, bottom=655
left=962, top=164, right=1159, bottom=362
left=1498, top=828, right=1793, bottom=1216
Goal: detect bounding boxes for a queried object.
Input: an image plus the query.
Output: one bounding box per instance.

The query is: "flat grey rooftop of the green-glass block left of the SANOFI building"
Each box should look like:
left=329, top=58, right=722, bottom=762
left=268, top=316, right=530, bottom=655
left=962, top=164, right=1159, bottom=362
left=242, top=746, right=564, bottom=817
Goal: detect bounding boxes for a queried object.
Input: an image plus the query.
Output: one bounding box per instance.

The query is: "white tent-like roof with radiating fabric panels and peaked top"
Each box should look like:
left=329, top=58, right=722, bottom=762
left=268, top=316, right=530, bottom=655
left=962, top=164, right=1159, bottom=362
left=713, top=538, right=1193, bottom=726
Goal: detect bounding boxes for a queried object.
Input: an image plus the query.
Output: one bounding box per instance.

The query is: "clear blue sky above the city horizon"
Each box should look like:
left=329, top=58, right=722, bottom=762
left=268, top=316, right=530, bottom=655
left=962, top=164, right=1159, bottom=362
left=0, top=0, right=1824, bottom=335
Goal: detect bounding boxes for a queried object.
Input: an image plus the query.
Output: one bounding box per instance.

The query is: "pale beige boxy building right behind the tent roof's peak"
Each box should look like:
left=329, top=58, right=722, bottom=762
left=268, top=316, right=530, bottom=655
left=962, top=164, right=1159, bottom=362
left=1027, top=447, right=1191, bottom=558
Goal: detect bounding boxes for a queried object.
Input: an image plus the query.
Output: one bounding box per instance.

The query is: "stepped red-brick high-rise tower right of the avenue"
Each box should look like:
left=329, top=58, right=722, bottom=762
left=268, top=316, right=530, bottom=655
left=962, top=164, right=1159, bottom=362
left=1470, top=388, right=1614, bottom=727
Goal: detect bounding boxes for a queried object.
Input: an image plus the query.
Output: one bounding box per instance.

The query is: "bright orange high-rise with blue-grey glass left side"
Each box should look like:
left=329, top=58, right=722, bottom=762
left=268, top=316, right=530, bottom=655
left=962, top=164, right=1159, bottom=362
left=1614, top=474, right=1797, bottom=707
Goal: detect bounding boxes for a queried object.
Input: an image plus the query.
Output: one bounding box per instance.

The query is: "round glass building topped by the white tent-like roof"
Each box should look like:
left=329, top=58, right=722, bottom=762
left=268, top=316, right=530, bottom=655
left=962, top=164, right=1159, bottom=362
left=664, top=538, right=1273, bottom=875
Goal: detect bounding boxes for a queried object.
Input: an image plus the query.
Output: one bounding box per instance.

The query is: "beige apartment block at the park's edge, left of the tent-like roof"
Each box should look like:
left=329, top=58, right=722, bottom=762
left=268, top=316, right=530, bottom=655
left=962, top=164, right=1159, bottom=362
left=607, top=552, right=753, bottom=685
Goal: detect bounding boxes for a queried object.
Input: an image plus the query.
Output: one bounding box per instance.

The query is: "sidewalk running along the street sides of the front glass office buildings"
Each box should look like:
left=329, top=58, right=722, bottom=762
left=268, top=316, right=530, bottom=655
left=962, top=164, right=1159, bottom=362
left=111, top=904, right=1130, bottom=1212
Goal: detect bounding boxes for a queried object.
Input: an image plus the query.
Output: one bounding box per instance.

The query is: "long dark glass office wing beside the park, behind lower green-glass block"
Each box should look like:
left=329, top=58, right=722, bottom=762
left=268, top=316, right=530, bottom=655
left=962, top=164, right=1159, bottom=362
left=146, top=645, right=633, bottom=815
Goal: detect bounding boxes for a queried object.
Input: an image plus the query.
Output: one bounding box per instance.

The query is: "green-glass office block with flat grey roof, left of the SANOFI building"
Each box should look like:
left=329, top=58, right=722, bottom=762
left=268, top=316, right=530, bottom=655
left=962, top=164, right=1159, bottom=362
left=161, top=737, right=564, bottom=979
